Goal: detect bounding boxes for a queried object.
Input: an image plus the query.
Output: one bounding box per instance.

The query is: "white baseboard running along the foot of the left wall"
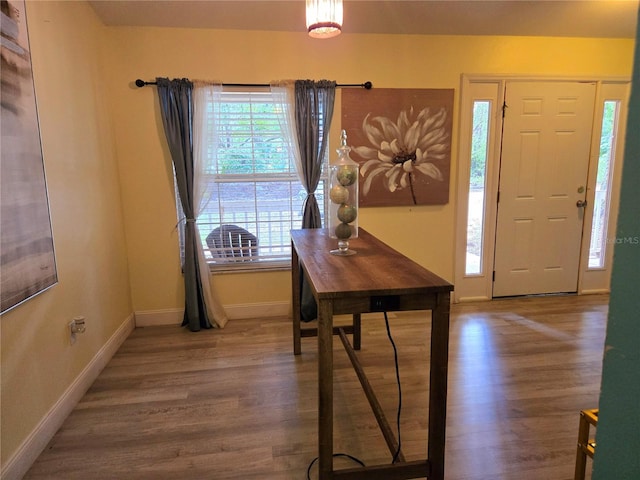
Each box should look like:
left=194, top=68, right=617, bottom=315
left=0, top=315, right=134, bottom=480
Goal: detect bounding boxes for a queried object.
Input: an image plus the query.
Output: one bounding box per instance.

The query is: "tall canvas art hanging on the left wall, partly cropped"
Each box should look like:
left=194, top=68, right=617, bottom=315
left=0, top=0, right=57, bottom=312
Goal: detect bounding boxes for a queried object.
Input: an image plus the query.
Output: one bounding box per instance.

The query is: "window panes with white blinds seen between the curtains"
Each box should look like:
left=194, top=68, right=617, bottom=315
left=178, top=91, right=328, bottom=269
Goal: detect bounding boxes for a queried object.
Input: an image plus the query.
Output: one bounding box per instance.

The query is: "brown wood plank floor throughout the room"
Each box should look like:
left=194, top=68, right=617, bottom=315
left=25, top=295, right=609, bottom=480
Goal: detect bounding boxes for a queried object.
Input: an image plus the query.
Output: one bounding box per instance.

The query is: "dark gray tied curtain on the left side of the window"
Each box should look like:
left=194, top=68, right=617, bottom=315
left=156, top=78, right=213, bottom=332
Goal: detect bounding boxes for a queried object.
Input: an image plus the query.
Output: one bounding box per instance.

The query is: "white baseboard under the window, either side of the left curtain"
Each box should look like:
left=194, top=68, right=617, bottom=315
left=135, top=301, right=291, bottom=327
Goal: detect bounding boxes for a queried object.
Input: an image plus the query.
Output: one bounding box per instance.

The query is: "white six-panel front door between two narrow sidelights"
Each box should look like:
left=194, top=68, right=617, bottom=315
left=493, top=81, right=596, bottom=297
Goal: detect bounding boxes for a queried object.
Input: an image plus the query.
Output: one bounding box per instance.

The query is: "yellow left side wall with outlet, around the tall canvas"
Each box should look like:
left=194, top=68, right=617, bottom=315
left=0, top=2, right=132, bottom=470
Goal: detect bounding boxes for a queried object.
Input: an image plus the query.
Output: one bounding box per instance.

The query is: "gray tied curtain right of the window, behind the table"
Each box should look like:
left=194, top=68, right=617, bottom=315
left=295, top=80, right=336, bottom=322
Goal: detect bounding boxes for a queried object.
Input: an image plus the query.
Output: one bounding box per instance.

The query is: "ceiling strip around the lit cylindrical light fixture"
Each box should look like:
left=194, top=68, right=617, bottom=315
left=89, top=0, right=639, bottom=38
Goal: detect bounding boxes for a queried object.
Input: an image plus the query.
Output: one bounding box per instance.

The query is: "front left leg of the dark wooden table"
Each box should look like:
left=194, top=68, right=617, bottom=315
left=318, top=300, right=333, bottom=480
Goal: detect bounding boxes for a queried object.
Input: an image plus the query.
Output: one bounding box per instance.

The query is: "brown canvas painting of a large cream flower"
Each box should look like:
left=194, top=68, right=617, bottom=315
left=342, top=88, right=453, bottom=207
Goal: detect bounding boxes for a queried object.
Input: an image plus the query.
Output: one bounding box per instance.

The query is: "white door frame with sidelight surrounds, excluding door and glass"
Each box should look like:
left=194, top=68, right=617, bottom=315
left=453, top=74, right=630, bottom=302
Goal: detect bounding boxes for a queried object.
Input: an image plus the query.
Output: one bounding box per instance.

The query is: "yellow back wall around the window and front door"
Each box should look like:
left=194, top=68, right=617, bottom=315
left=102, top=27, right=633, bottom=312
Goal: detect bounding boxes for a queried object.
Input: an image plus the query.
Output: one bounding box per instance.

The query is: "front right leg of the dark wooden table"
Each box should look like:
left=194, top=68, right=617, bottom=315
left=427, top=292, right=450, bottom=480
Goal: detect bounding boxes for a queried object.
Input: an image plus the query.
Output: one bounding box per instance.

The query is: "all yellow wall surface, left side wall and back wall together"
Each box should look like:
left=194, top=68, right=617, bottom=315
left=1, top=2, right=633, bottom=472
